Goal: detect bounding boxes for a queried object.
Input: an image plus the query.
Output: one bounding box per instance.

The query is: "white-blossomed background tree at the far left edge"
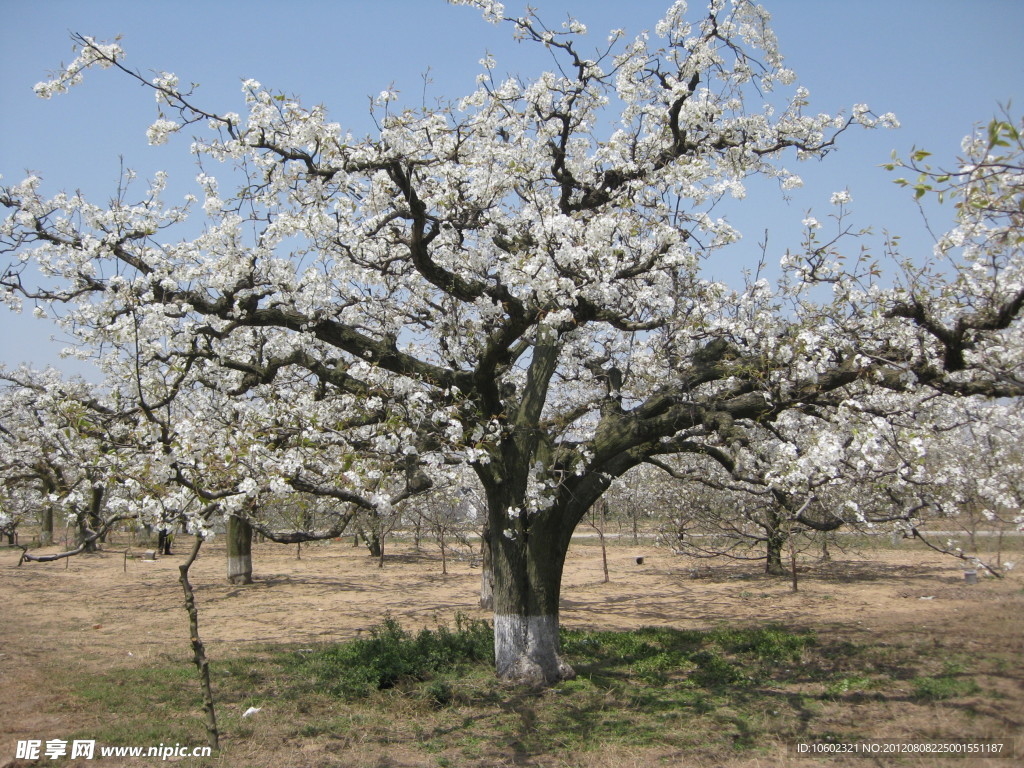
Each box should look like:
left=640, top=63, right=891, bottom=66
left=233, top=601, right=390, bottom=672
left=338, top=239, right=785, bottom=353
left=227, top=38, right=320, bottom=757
left=0, top=368, right=235, bottom=561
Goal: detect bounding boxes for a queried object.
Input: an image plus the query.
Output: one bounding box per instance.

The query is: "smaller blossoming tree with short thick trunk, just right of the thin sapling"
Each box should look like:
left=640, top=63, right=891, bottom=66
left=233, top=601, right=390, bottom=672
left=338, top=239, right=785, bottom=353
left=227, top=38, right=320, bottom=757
left=106, top=349, right=429, bottom=584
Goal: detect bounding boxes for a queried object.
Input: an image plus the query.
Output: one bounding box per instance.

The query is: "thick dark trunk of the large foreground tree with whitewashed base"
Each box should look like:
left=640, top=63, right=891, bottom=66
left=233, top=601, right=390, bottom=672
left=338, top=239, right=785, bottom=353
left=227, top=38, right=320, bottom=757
left=490, top=505, right=575, bottom=687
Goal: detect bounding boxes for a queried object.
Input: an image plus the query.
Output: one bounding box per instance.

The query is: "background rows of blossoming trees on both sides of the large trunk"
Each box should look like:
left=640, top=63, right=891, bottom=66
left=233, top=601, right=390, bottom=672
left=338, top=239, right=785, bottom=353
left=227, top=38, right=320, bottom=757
left=6, top=370, right=1024, bottom=584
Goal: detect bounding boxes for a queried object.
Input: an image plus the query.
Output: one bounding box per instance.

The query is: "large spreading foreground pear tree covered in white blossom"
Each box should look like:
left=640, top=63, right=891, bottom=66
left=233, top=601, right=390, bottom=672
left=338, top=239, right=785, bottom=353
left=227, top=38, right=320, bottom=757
left=0, top=0, right=1024, bottom=684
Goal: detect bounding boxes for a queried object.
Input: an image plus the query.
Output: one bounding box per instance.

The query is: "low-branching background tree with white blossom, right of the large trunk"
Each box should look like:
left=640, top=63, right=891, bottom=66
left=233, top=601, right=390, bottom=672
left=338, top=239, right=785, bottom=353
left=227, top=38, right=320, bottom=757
left=649, top=386, right=930, bottom=575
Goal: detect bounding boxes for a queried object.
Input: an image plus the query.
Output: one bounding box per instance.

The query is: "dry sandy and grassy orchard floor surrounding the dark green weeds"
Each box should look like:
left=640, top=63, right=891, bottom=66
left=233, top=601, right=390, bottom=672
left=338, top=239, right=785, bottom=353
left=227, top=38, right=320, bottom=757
left=0, top=542, right=1024, bottom=768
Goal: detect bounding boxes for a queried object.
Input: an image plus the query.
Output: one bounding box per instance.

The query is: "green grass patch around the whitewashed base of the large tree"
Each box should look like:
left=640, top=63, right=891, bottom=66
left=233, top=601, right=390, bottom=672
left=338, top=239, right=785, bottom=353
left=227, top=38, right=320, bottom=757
left=64, top=616, right=991, bottom=766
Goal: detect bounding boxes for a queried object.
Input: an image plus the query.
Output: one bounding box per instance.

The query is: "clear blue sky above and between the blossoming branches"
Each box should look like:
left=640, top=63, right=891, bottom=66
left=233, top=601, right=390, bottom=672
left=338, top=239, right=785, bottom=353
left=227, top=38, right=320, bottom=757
left=0, top=0, right=1024, bottom=372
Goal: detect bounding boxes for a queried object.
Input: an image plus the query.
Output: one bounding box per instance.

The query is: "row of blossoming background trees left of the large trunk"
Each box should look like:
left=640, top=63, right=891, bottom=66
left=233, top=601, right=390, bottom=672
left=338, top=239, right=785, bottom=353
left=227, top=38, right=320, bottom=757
left=0, top=368, right=480, bottom=583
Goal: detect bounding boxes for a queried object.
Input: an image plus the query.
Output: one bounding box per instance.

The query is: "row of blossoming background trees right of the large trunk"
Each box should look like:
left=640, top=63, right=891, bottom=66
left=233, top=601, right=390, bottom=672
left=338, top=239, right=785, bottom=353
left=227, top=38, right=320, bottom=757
left=609, top=396, right=1024, bottom=575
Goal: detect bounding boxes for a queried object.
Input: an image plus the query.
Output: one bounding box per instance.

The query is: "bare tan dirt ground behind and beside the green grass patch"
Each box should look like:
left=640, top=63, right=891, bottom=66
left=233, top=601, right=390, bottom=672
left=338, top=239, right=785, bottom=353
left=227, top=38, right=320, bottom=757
left=0, top=540, right=1024, bottom=766
